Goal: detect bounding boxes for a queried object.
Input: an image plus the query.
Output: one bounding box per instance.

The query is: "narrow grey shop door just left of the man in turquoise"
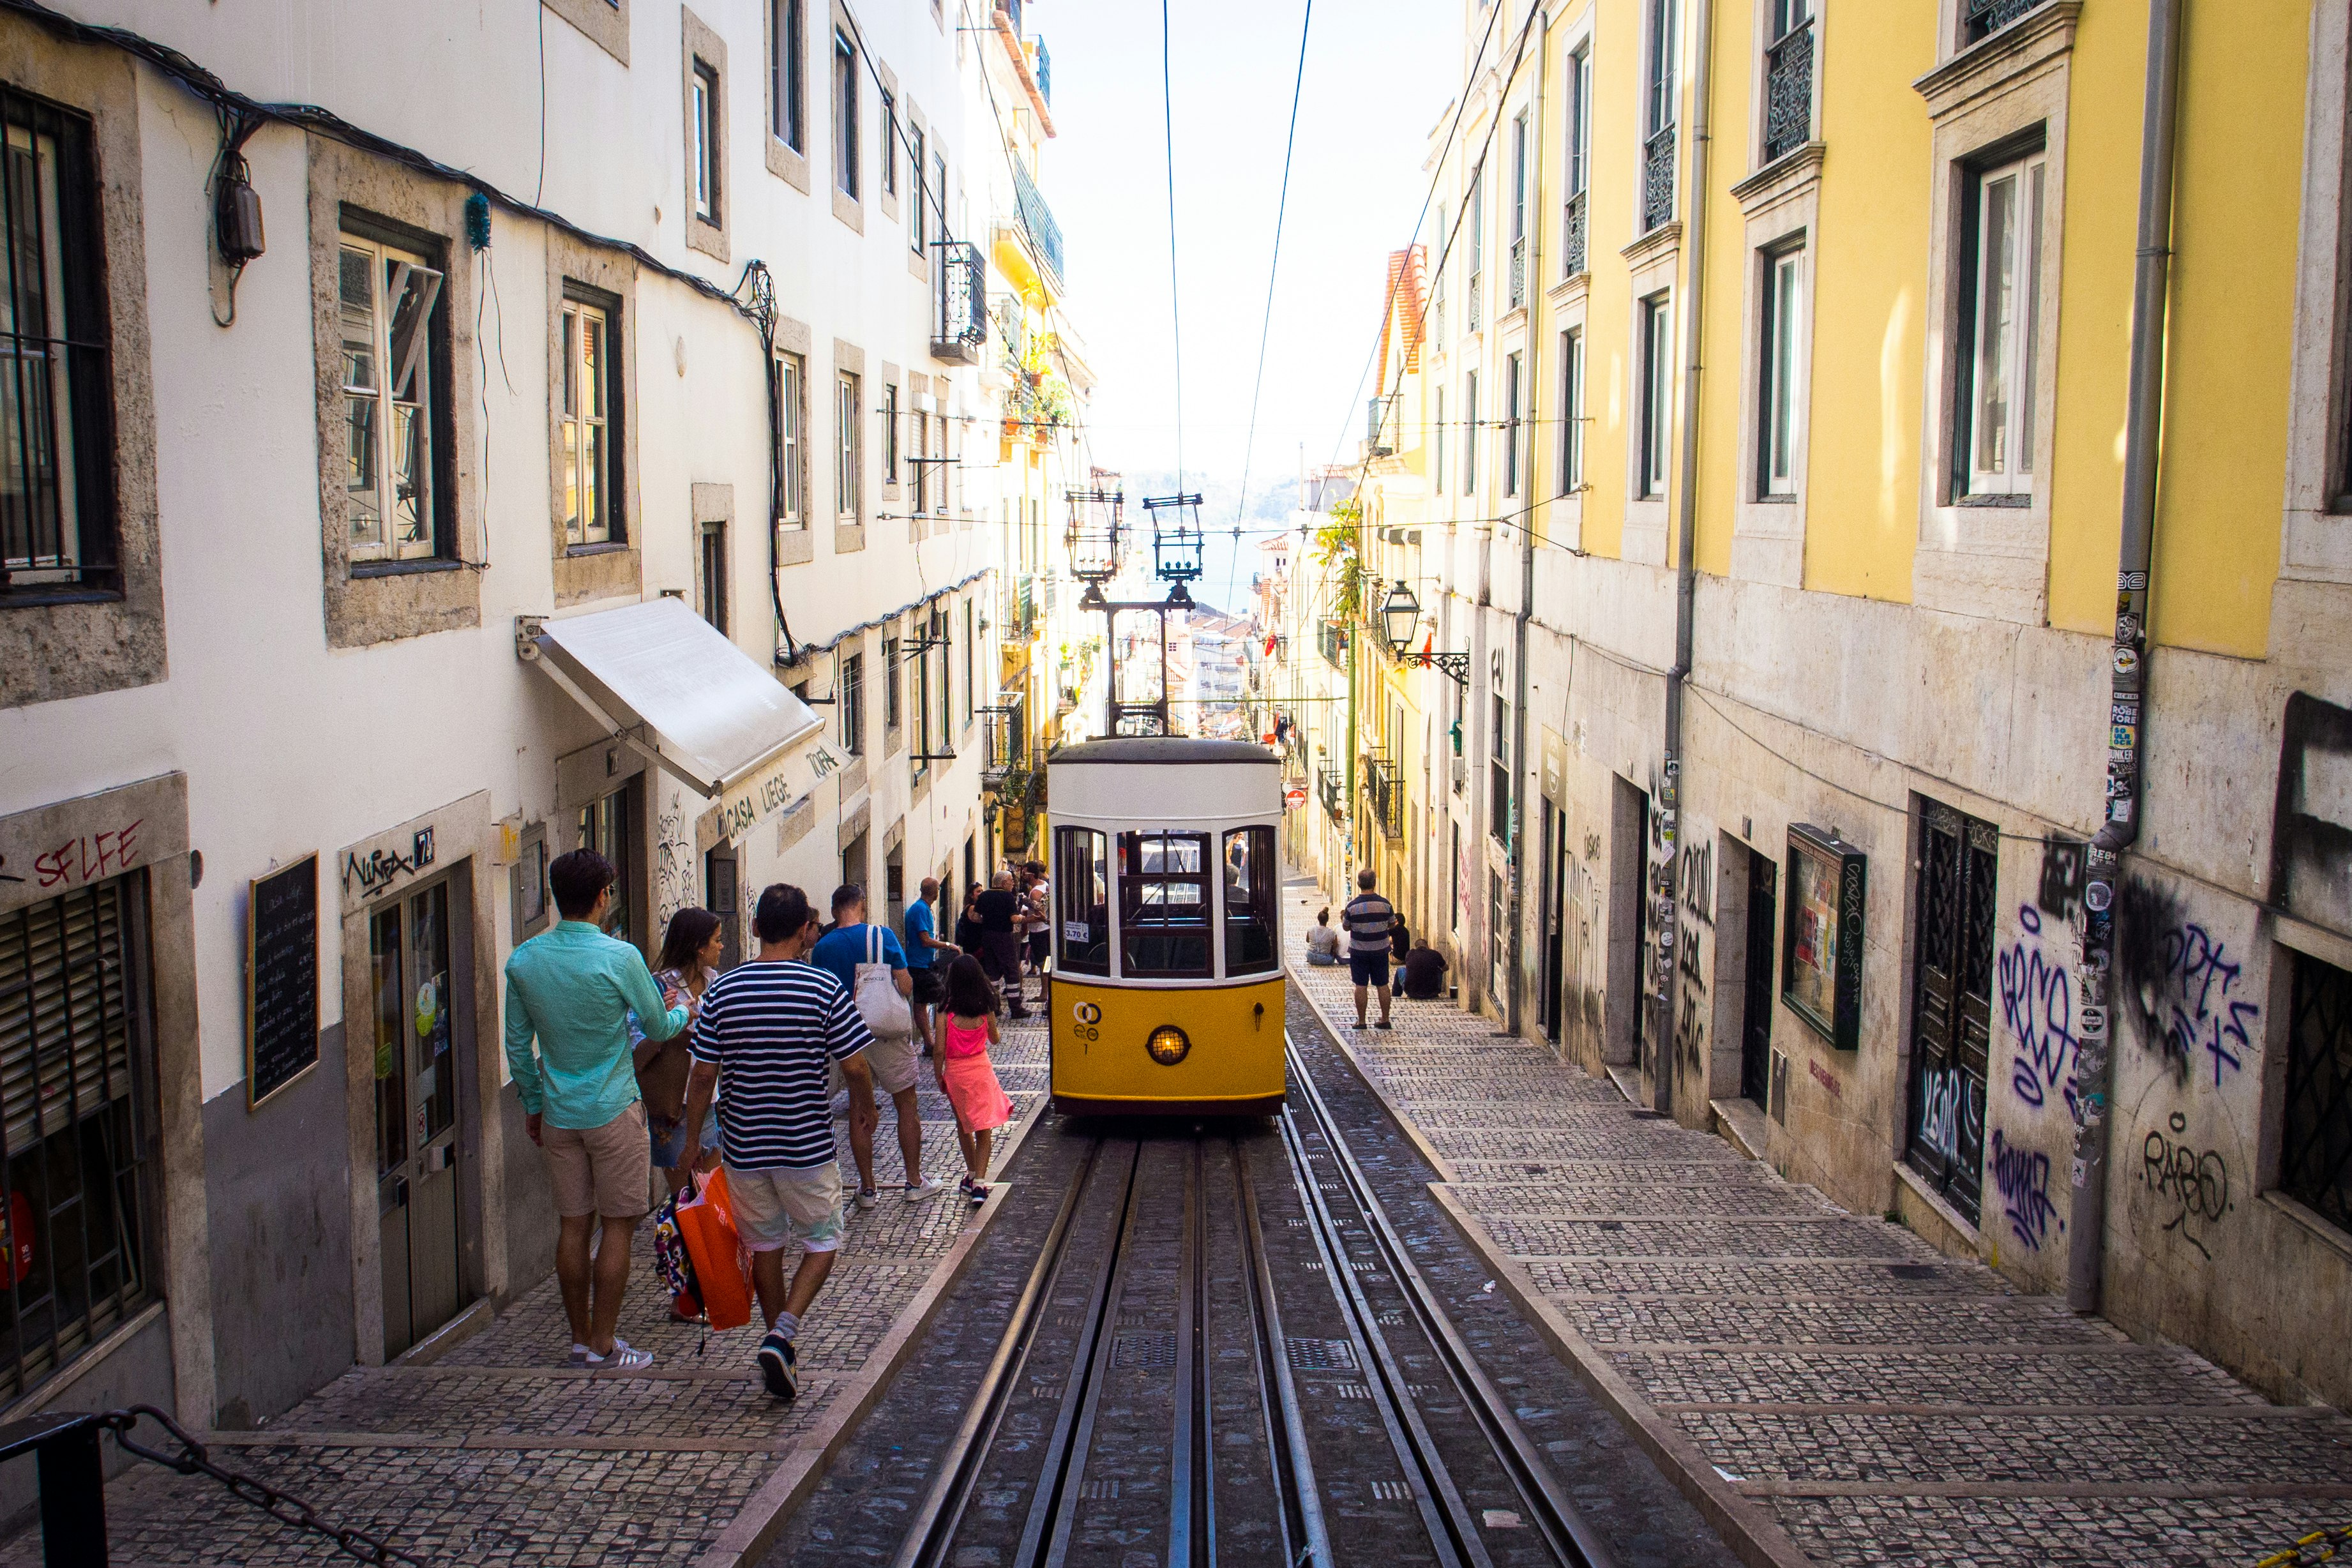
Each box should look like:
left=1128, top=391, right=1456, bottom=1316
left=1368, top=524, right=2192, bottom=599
left=369, top=882, right=472, bottom=1359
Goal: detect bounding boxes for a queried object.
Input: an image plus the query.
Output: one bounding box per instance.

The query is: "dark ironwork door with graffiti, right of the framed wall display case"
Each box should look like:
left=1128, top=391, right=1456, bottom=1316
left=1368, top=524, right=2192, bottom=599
left=1903, top=802, right=2001, bottom=1225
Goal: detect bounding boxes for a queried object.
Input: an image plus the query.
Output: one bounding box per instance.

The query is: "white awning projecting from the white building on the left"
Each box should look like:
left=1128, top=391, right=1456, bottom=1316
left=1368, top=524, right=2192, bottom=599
left=539, top=599, right=823, bottom=797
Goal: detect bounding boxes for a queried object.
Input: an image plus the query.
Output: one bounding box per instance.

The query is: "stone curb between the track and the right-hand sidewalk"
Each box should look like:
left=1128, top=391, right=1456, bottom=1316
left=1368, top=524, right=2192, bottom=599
left=1292, top=959, right=1818, bottom=1568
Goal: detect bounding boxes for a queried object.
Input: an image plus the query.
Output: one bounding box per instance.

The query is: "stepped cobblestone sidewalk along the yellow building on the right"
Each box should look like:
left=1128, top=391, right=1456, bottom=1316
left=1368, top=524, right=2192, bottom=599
left=1292, top=889, right=2352, bottom=1568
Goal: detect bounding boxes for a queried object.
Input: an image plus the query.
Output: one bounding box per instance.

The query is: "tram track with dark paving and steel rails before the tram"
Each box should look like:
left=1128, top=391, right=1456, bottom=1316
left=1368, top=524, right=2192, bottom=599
left=896, top=1029, right=1611, bottom=1568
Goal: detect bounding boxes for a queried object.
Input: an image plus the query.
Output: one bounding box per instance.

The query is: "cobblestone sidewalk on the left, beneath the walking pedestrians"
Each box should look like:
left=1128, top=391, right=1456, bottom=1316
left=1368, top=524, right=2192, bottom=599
left=0, top=1020, right=1046, bottom=1568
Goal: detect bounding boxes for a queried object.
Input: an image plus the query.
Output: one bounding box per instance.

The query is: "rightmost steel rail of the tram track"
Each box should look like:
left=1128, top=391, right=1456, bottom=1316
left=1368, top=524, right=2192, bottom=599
left=1284, top=1030, right=1616, bottom=1568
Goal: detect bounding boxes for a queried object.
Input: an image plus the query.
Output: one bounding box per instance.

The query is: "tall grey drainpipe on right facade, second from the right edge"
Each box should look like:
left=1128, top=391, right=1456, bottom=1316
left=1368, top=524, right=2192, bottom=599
left=1641, top=0, right=1715, bottom=1110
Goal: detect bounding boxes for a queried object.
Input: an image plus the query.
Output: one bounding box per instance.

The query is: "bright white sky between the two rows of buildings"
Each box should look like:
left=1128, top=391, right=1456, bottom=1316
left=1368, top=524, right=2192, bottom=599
left=1023, top=0, right=1461, bottom=587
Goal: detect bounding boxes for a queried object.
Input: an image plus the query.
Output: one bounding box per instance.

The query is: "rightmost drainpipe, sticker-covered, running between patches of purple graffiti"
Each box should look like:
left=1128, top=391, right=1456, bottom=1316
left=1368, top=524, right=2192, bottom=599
left=2065, top=0, right=2180, bottom=1312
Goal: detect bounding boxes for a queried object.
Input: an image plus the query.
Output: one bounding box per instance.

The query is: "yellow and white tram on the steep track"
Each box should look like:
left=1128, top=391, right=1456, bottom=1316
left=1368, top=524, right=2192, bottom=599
left=1046, top=738, right=1284, bottom=1117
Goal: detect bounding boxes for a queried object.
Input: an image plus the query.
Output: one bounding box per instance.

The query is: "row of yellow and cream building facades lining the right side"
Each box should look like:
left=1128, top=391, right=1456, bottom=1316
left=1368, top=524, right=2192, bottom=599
left=1345, top=0, right=2352, bottom=1403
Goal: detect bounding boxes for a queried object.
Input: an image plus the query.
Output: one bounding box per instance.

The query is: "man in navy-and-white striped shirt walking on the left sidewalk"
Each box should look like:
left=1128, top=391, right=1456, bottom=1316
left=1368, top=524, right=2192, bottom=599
left=684, top=882, right=873, bottom=1399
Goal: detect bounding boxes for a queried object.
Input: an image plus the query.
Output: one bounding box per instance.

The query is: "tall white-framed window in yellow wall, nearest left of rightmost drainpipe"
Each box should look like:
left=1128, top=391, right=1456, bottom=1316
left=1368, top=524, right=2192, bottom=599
left=1954, top=151, right=2042, bottom=496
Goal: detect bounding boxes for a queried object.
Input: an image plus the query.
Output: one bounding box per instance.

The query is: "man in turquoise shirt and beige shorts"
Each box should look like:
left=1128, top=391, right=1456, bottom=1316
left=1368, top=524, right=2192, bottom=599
left=506, top=848, right=687, bottom=1371
